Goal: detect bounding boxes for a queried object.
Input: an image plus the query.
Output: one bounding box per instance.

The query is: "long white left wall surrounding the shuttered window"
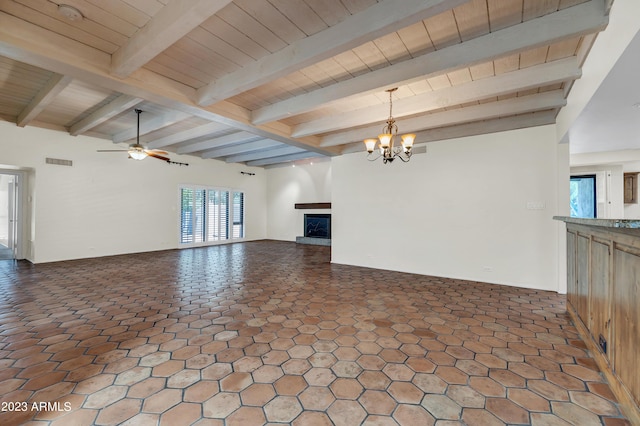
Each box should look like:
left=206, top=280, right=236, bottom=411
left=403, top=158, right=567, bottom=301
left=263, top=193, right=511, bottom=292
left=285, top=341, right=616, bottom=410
left=0, top=122, right=266, bottom=263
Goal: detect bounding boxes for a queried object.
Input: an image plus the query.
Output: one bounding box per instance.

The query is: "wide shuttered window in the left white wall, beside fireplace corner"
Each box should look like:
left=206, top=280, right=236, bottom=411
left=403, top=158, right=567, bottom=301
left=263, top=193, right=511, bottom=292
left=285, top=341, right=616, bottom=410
left=180, top=187, right=244, bottom=245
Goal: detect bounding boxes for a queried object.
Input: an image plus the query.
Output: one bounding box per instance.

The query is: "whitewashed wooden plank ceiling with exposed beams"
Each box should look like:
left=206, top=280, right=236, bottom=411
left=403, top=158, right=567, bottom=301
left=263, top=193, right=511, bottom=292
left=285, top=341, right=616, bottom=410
left=0, top=0, right=609, bottom=167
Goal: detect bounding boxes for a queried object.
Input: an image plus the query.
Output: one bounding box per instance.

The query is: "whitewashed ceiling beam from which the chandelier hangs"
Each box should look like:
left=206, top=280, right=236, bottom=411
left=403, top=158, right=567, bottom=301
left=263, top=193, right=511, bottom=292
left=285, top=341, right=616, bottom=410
left=292, top=56, right=582, bottom=137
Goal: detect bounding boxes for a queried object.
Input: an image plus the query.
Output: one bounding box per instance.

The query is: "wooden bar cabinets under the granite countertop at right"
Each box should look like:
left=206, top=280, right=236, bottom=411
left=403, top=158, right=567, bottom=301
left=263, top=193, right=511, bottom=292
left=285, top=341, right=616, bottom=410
left=565, top=219, right=640, bottom=425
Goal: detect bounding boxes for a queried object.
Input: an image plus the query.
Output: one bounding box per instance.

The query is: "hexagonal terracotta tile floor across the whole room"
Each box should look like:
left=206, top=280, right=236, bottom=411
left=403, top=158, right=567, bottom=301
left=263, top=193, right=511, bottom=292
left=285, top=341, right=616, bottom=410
left=0, top=241, right=629, bottom=426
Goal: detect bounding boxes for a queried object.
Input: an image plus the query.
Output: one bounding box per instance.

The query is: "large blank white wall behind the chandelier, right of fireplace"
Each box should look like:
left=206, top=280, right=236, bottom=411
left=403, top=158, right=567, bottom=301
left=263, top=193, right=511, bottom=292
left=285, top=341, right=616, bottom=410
left=332, top=126, right=569, bottom=292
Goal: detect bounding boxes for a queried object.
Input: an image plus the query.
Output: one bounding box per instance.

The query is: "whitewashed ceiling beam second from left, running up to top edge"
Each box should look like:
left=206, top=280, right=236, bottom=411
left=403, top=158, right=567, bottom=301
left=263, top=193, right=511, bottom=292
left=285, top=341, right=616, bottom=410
left=198, top=0, right=468, bottom=105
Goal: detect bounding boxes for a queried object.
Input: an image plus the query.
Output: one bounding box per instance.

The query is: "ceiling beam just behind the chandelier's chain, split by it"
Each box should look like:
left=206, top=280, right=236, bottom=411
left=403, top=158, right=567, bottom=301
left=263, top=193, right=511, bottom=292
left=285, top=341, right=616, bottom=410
left=322, top=90, right=567, bottom=146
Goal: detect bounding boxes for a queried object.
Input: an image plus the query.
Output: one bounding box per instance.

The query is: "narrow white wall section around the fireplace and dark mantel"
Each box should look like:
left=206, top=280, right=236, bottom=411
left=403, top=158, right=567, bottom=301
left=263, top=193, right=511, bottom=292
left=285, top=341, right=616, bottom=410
left=267, top=161, right=331, bottom=241
